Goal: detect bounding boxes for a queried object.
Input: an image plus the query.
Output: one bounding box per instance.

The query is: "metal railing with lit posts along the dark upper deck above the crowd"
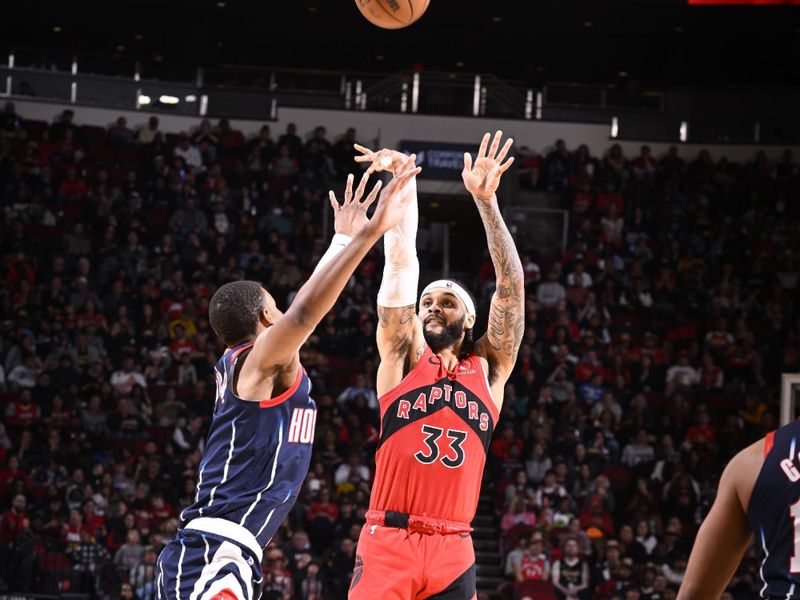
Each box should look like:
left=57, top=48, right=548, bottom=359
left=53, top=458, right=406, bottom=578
left=0, top=49, right=800, bottom=143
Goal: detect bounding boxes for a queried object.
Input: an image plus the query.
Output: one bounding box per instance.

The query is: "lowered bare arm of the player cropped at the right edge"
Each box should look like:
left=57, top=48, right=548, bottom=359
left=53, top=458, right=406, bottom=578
left=678, top=440, right=764, bottom=600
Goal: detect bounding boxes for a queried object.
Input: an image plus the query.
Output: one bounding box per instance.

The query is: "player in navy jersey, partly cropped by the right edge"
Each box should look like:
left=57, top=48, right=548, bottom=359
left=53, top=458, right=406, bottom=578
left=678, top=421, right=800, bottom=600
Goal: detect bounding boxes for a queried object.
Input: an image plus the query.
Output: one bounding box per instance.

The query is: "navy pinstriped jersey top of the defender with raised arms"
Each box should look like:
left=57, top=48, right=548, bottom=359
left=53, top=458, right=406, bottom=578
left=181, top=344, right=317, bottom=548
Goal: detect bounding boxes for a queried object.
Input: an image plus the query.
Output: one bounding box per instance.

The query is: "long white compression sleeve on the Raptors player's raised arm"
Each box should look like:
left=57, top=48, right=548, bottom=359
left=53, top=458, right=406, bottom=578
left=378, top=172, right=419, bottom=308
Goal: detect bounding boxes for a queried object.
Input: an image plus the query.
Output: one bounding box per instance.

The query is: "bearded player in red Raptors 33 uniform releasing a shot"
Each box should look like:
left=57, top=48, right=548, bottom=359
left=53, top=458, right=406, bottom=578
left=349, top=131, right=524, bottom=600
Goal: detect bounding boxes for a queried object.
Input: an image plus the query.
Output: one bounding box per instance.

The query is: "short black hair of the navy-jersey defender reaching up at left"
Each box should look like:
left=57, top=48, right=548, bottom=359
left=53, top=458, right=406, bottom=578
left=208, top=281, right=264, bottom=348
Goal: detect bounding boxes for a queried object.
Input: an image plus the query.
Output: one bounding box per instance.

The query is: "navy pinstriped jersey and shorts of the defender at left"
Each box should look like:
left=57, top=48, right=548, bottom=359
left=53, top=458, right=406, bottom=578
left=158, top=343, right=317, bottom=600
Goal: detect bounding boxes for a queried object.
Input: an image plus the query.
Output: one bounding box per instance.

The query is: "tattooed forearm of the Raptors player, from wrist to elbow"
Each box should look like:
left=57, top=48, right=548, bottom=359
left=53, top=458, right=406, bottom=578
left=476, top=200, right=525, bottom=364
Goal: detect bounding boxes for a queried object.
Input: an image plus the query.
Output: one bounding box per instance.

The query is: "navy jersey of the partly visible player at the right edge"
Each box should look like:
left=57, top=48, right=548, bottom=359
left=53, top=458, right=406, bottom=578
left=747, top=421, right=800, bottom=600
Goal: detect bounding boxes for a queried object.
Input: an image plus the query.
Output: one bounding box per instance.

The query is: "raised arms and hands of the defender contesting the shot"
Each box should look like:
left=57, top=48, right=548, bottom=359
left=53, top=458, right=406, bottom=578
left=252, top=158, right=420, bottom=369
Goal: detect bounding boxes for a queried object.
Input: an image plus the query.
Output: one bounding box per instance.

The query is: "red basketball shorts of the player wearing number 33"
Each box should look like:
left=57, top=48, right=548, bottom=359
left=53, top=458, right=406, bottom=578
left=348, top=511, right=477, bottom=600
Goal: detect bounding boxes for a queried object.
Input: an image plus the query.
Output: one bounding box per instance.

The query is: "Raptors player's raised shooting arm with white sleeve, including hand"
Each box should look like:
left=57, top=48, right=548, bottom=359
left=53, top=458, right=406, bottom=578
left=355, top=144, right=425, bottom=396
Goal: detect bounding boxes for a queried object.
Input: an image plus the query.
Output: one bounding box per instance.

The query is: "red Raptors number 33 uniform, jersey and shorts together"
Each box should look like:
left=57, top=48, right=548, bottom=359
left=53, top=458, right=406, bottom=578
left=349, top=348, right=499, bottom=599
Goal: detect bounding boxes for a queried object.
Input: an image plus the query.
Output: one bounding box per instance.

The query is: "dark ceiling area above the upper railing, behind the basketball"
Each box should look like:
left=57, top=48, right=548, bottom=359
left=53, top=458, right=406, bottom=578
left=0, top=0, right=800, bottom=86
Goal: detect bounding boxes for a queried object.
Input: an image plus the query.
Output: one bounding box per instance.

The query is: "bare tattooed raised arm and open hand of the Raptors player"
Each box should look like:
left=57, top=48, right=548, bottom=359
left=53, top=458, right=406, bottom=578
left=461, top=131, right=525, bottom=394
